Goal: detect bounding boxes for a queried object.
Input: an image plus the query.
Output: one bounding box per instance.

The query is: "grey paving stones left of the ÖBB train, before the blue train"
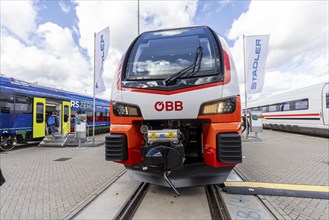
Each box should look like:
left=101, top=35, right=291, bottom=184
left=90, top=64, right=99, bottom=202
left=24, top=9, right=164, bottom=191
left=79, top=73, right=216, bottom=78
left=0, top=135, right=123, bottom=219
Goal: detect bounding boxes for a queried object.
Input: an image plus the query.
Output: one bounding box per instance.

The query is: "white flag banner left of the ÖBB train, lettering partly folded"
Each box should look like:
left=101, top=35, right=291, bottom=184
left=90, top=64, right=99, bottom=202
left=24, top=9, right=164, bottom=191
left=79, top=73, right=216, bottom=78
left=94, top=27, right=110, bottom=94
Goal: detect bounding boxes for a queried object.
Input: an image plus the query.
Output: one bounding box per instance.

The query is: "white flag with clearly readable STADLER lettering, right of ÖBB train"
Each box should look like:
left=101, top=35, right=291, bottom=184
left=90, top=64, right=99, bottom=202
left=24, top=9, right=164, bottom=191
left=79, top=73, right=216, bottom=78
left=245, top=35, right=270, bottom=94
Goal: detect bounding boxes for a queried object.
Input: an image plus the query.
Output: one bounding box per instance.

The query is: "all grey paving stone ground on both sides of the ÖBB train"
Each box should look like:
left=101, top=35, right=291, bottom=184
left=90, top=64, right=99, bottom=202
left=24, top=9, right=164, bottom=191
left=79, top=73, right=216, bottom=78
left=0, top=130, right=329, bottom=220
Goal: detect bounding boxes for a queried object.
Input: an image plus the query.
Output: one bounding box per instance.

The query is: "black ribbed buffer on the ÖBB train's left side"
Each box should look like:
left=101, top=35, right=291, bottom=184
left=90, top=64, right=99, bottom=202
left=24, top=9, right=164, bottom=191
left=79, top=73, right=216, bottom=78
left=105, top=134, right=128, bottom=161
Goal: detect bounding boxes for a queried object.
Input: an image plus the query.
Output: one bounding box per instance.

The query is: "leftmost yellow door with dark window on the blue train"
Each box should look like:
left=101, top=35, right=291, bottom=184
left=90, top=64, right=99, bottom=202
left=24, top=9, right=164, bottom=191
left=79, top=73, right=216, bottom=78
left=33, top=97, right=46, bottom=138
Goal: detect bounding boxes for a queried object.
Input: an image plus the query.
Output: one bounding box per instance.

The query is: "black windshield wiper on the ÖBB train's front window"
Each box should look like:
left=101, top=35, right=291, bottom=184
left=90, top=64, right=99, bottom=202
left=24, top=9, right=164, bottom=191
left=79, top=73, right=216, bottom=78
left=164, top=47, right=203, bottom=86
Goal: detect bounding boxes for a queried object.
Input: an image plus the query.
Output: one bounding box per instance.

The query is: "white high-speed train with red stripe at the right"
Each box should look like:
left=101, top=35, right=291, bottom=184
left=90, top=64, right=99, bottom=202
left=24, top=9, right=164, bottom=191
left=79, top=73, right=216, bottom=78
left=248, top=82, right=329, bottom=137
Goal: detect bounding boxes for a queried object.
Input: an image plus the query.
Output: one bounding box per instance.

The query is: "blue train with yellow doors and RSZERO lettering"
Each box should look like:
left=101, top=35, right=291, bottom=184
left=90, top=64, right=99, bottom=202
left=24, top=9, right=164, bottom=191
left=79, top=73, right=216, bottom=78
left=0, top=75, right=110, bottom=148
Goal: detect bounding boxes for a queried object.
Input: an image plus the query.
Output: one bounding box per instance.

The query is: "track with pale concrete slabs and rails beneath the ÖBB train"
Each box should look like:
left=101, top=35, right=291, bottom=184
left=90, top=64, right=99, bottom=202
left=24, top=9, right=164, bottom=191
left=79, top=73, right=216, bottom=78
left=73, top=172, right=275, bottom=220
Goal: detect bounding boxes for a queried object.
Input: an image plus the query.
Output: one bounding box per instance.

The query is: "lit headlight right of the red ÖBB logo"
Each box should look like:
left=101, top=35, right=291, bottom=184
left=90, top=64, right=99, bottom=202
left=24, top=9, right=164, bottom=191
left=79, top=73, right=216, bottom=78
left=199, top=97, right=236, bottom=115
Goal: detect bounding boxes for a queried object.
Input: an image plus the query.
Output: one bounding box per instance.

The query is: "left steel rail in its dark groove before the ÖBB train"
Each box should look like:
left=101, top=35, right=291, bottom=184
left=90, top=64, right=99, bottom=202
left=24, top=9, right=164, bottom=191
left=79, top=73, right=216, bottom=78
left=114, top=183, right=150, bottom=220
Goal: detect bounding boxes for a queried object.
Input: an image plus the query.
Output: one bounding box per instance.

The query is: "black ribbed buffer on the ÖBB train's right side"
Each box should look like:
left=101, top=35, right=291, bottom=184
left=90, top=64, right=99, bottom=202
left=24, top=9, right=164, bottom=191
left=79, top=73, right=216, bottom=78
left=217, top=133, right=242, bottom=163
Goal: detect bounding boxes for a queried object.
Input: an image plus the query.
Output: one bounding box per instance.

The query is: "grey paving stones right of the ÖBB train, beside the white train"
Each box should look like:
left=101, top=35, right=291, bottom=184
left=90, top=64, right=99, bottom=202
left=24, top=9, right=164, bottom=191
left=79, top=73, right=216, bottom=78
left=235, top=130, right=329, bottom=220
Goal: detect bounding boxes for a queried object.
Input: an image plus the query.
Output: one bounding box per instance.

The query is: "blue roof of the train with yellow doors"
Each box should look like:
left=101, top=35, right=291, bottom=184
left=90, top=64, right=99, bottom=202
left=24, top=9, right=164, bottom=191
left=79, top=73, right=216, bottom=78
left=0, top=75, right=109, bottom=104
